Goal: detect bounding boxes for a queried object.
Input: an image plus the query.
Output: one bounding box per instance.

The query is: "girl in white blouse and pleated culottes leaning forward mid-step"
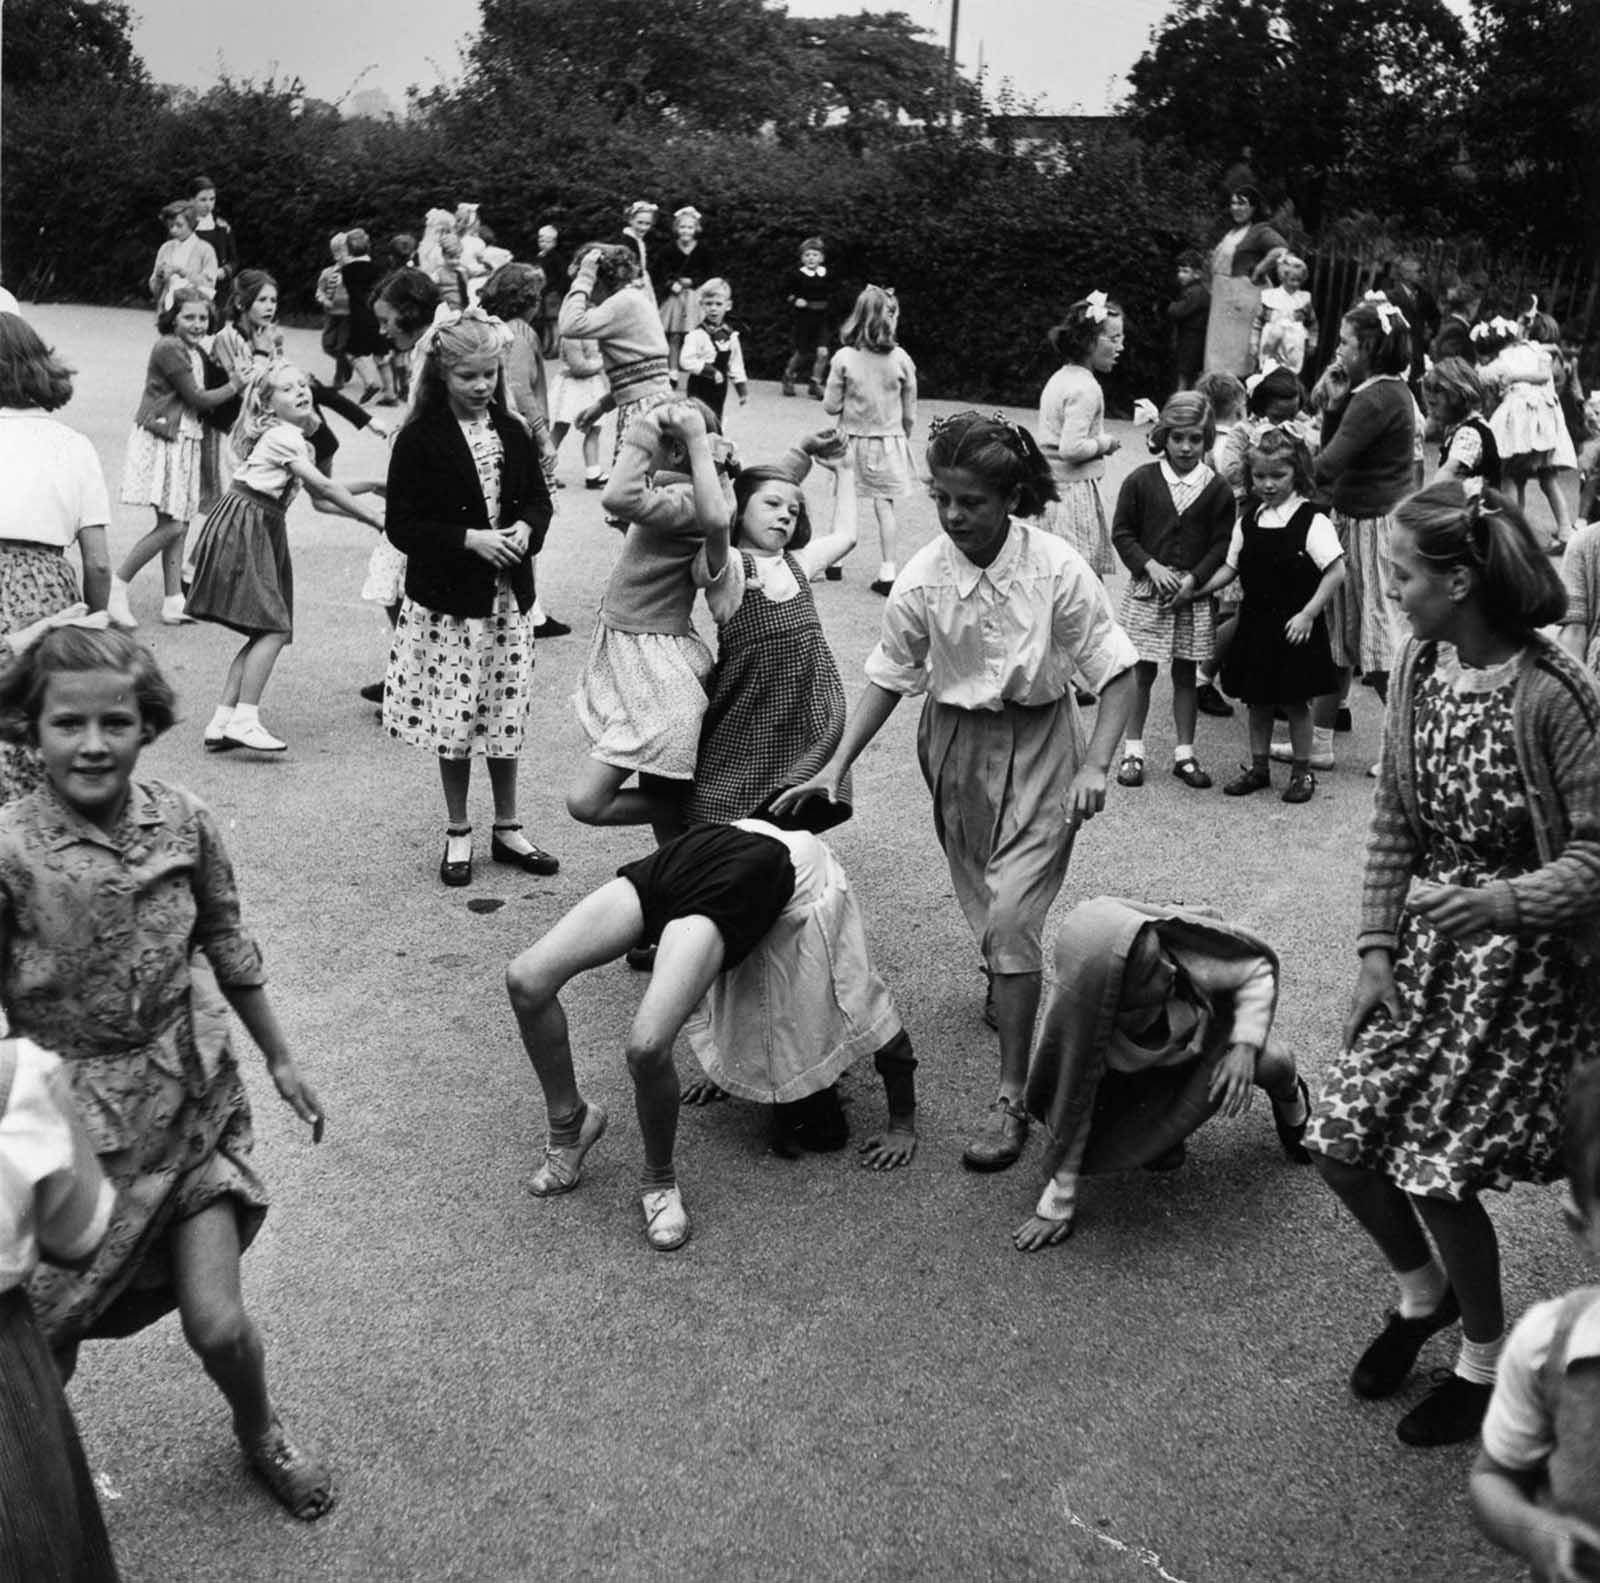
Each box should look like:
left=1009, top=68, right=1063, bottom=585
left=773, top=411, right=1139, bottom=1170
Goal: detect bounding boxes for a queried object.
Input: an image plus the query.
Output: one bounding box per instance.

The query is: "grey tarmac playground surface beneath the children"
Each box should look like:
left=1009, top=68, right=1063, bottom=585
left=29, top=307, right=1579, bottom=1583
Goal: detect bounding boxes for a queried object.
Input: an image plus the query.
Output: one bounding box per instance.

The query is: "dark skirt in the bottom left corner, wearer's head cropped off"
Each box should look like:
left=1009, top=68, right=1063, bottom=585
left=0, top=1287, right=117, bottom=1583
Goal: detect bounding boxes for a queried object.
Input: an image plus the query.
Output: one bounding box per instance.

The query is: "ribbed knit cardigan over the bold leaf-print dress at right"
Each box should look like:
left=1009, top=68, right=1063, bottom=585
left=1355, top=634, right=1600, bottom=957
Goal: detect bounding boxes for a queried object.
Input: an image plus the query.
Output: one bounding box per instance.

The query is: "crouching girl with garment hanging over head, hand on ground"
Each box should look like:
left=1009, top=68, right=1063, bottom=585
left=1011, top=896, right=1310, bottom=1253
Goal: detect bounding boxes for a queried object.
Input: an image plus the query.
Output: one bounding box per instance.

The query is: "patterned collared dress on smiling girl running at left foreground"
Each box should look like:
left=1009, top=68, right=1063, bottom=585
left=0, top=781, right=267, bottom=1348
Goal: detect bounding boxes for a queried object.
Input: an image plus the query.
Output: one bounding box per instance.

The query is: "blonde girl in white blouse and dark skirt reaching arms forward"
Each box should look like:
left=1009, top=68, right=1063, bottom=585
left=184, top=364, right=384, bottom=752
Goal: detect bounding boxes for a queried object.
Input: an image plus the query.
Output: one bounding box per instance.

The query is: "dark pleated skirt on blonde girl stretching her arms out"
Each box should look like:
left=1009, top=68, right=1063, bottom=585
left=184, top=483, right=294, bottom=637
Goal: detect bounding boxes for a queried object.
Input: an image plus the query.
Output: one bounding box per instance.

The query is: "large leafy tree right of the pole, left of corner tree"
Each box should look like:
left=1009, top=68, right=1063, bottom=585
left=1128, top=0, right=1465, bottom=229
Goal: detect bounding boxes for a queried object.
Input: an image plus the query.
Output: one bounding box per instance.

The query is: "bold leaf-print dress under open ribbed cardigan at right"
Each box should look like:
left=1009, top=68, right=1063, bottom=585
left=1306, top=645, right=1595, bottom=1200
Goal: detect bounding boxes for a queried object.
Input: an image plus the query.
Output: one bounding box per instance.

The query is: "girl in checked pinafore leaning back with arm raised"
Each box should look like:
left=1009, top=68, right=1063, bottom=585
left=688, top=432, right=856, bottom=828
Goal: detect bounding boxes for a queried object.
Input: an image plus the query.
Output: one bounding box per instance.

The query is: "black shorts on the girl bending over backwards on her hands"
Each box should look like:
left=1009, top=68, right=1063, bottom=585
left=618, top=824, right=795, bottom=972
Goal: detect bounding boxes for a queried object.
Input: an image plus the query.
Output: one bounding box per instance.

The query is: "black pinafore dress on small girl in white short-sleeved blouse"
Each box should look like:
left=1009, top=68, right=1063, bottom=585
left=1222, top=501, right=1339, bottom=704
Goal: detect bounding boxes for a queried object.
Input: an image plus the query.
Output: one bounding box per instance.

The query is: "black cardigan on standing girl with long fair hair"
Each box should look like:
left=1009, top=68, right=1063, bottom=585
left=384, top=408, right=550, bottom=618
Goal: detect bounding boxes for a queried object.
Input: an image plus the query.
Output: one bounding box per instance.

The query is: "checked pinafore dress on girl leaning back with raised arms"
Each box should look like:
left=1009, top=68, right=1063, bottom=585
left=690, top=551, right=850, bottom=824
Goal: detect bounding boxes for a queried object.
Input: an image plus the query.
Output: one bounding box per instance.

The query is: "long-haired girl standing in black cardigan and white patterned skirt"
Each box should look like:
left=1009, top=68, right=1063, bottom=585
left=384, top=309, right=560, bottom=885
